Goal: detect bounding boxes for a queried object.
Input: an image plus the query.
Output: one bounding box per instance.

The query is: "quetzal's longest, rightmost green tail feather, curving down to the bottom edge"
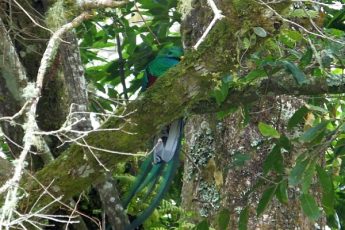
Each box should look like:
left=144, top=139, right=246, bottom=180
left=125, top=151, right=179, bottom=230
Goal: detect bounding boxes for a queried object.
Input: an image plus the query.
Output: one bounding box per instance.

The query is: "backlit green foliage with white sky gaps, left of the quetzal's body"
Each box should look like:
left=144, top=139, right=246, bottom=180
left=78, top=0, right=181, bottom=111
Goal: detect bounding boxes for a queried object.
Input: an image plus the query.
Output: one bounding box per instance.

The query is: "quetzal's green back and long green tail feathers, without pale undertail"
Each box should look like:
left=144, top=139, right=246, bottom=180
left=122, top=46, right=183, bottom=230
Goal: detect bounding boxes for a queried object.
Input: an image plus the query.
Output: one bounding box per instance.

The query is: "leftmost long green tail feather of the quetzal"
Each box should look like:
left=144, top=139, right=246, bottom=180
left=122, top=154, right=153, bottom=209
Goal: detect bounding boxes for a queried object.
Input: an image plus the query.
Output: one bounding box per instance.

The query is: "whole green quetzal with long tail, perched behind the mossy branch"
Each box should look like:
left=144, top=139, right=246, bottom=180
left=122, top=46, right=183, bottom=230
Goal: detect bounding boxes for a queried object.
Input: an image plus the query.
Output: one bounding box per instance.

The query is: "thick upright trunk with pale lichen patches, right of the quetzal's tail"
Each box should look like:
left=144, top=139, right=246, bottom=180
left=181, top=1, right=325, bottom=229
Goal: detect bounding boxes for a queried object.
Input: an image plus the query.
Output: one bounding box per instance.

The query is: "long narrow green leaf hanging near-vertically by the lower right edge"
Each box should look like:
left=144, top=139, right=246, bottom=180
left=316, top=165, right=335, bottom=216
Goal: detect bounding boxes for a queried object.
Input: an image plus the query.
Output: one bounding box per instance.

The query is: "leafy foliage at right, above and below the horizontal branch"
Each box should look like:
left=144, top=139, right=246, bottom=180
left=214, top=2, right=345, bottom=229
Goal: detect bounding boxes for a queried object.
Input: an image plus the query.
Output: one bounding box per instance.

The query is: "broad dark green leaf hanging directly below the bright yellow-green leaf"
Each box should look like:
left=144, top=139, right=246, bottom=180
left=263, top=145, right=284, bottom=175
